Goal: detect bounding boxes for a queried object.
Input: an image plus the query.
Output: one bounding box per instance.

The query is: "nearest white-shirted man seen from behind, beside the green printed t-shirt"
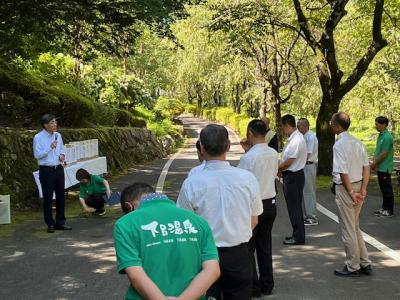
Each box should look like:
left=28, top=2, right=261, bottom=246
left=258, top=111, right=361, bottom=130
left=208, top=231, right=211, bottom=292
left=177, top=124, right=263, bottom=300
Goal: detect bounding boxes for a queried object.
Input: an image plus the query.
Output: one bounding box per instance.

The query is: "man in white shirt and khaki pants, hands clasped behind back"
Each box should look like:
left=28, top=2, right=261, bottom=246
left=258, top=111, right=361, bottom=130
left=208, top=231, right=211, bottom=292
left=331, top=112, right=372, bottom=277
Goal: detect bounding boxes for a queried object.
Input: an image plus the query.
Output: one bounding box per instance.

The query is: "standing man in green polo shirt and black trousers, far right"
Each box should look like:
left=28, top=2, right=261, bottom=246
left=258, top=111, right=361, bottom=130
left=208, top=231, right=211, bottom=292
left=371, top=116, right=394, bottom=217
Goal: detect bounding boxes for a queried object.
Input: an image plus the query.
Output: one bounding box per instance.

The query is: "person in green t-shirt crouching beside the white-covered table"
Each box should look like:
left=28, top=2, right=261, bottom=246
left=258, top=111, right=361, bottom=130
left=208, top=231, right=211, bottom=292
left=76, top=169, right=111, bottom=216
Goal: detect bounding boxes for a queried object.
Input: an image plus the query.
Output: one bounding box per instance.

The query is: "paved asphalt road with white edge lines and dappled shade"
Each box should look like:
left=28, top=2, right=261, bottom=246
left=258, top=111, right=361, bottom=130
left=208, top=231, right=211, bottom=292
left=0, top=116, right=400, bottom=300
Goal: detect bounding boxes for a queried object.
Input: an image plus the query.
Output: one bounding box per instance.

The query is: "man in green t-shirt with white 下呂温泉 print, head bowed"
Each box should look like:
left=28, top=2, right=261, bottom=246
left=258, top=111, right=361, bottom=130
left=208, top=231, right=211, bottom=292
left=114, top=183, right=220, bottom=300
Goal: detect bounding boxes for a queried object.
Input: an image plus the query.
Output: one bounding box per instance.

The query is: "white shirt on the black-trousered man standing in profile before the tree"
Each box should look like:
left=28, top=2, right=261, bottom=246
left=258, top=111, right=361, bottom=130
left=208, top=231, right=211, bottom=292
left=281, top=129, right=307, bottom=172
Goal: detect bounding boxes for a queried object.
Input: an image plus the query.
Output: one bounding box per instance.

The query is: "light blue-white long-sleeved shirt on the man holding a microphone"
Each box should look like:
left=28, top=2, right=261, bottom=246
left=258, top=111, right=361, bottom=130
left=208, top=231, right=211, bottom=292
left=33, top=129, right=65, bottom=166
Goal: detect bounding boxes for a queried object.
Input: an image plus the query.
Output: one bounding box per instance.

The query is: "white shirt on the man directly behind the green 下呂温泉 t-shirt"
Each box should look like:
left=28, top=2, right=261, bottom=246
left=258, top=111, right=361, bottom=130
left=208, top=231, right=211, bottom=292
left=177, top=161, right=263, bottom=247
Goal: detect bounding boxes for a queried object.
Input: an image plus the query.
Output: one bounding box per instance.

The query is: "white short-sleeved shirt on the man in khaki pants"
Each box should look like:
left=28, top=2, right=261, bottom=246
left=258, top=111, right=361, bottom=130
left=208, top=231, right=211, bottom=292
left=332, top=131, right=369, bottom=184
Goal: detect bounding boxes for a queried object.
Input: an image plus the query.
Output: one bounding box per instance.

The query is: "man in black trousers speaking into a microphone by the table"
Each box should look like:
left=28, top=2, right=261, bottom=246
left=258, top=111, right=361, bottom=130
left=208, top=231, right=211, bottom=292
left=33, top=114, right=71, bottom=233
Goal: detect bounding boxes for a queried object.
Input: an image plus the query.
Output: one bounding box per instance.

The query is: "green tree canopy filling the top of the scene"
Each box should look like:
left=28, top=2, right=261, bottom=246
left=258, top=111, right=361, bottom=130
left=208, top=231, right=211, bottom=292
left=0, top=0, right=400, bottom=173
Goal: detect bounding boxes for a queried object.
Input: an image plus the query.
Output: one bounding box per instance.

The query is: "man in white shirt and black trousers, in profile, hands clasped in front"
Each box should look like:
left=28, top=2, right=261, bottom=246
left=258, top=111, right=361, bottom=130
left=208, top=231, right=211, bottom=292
left=279, top=115, right=307, bottom=245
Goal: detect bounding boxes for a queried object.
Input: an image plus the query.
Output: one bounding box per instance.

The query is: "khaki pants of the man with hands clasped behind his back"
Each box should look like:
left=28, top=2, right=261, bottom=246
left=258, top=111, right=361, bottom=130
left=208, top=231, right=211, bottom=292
left=336, top=182, right=371, bottom=271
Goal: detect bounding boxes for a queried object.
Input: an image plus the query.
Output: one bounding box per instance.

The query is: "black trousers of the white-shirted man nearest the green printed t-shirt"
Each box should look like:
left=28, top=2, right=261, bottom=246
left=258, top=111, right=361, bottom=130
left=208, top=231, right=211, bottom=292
left=207, top=243, right=251, bottom=300
